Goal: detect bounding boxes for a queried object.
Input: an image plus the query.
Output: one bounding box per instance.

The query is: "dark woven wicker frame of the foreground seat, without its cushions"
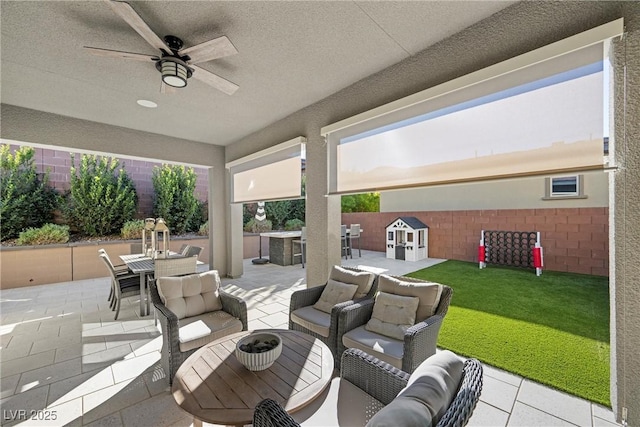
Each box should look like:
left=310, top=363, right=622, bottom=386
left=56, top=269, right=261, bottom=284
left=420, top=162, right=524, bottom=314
left=253, top=349, right=483, bottom=427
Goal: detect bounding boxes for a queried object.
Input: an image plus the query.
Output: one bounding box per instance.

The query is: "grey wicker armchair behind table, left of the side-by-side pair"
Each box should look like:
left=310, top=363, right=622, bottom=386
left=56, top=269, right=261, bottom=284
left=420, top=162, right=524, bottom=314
left=289, top=266, right=377, bottom=368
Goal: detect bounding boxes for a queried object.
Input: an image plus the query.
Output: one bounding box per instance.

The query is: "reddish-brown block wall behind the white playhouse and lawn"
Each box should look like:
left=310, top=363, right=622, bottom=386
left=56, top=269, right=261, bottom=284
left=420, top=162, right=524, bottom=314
left=342, top=208, right=609, bottom=276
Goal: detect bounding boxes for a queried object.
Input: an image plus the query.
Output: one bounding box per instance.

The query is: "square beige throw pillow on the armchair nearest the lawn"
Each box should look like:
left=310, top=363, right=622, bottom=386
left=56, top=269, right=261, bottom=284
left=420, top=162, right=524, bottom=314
left=364, top=292, right=420, bottom=340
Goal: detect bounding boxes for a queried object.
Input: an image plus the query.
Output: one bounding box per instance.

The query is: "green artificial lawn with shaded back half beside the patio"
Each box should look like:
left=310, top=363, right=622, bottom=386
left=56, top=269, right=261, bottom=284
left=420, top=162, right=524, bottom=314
left=408, top=261, right=611, bottom=406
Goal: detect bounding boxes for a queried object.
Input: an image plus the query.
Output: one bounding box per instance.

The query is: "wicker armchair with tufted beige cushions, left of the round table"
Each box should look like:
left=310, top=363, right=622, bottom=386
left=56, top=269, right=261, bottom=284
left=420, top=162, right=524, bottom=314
left=150, top=270, right=248, bottom=384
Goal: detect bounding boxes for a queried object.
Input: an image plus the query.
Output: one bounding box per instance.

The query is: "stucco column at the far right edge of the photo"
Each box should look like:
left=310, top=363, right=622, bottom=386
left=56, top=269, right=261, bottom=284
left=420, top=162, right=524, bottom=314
left=609, top=2, right=640, bottom=426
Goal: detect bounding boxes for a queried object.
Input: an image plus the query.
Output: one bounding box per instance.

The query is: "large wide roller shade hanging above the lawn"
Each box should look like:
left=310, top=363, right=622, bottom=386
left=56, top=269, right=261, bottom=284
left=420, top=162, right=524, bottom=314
left=322, top=20, right=622, bottom=193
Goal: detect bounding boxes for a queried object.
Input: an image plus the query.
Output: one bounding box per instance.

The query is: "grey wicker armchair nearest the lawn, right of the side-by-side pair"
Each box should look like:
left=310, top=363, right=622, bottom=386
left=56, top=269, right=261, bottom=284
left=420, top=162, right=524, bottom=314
left=336, top=275, right=453, bottom=373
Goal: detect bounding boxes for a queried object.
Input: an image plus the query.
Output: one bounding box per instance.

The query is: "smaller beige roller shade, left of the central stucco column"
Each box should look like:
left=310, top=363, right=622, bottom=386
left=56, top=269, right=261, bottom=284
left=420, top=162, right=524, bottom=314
left=226, top=137, right=306, bottom=203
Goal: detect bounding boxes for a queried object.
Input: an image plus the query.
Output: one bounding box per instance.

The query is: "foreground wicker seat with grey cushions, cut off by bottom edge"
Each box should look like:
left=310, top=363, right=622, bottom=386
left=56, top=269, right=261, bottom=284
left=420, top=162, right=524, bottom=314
left=253, top=348, right=483, bottom=427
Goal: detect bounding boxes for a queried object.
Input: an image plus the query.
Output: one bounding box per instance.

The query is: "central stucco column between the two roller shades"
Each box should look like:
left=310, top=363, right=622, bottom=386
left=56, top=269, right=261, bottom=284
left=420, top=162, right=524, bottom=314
left=305, top=134, right=341, bottom=287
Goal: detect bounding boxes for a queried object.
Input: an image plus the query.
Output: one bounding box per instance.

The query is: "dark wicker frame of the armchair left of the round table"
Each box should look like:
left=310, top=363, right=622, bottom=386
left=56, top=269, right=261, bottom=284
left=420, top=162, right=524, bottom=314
left=150, top=270, right=248, bottom=385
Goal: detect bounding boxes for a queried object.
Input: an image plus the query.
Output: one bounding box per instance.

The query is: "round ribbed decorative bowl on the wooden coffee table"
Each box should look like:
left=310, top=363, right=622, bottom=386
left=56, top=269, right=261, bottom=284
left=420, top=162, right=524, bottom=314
left=235, top=332, right=282, bottom=371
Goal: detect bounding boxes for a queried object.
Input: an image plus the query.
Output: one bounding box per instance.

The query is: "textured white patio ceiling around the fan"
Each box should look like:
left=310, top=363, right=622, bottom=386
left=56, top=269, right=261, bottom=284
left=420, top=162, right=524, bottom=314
left=0, top=0, right=514, bottom=145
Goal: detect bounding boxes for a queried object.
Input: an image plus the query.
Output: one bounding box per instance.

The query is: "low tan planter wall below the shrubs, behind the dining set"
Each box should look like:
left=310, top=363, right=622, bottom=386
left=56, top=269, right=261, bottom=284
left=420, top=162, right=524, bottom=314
left=0, top=238, right=209, bottom=289
